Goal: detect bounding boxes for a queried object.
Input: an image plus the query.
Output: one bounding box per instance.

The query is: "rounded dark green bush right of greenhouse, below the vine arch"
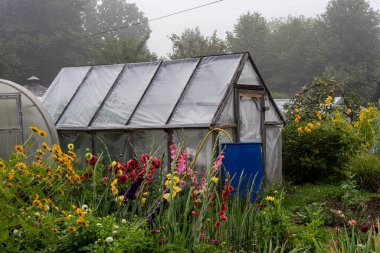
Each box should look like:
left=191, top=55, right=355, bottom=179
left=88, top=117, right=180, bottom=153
left=283, top=122, right=359, bottom=183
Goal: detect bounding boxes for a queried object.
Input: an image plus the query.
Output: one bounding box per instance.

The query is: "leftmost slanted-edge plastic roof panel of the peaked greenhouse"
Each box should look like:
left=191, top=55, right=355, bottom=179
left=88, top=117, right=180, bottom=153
left=42, top=66, right=91, bottom=122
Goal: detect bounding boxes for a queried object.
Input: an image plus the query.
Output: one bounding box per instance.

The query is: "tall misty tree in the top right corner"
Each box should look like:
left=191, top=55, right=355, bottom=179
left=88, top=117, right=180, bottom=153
left=319, top=0, right=380, bottom=98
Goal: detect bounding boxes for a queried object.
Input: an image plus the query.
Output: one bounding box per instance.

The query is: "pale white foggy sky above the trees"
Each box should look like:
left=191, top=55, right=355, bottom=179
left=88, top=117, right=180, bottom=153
left=128, top=0, right=380, bottom=56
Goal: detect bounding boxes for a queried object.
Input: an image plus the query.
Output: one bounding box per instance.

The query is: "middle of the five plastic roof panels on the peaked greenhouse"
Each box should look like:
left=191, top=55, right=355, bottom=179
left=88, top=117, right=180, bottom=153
left=92, top=62, right=159, bottom=127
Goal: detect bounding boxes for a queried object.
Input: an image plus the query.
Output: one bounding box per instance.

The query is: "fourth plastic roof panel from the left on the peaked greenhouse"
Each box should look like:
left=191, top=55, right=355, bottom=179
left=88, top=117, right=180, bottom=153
left=130, top=59, right=198, bottom=126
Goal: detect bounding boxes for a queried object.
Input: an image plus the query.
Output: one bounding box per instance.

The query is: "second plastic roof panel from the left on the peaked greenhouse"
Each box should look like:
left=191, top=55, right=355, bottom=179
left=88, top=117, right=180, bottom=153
left=58, top=64, right=124, bottom=127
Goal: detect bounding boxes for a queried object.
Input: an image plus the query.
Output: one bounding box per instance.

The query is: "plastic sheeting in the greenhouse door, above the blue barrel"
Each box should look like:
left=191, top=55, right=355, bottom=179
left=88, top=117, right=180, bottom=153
left=239, top=97, right=261, bottom=142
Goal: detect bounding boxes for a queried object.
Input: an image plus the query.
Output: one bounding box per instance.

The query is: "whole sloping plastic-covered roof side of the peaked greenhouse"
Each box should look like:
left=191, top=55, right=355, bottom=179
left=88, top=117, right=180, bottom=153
left=42, top=53, right=284, bottom=129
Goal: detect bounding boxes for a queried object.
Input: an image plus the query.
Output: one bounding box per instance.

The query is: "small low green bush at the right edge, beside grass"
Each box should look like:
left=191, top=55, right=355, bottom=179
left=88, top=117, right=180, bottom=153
left=347, top=153, right=380, bottom=191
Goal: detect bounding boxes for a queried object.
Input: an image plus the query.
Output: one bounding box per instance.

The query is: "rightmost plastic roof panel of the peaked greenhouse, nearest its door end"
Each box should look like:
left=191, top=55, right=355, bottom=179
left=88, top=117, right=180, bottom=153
left=170, top=55, right=242, bottom=125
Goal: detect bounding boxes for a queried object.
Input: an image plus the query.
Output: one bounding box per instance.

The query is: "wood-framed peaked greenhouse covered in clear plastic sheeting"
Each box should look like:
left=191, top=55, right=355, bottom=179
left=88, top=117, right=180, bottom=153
left=42, top=53, right=284, bottom=185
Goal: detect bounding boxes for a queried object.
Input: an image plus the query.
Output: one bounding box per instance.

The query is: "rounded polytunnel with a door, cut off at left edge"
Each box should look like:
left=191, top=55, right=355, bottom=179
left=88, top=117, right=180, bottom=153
left=0, top=79, right=59, bottom=160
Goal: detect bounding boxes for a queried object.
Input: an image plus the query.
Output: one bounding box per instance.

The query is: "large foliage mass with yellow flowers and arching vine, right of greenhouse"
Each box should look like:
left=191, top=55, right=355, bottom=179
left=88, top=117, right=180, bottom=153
left=283, top=78, right=379, bottom=183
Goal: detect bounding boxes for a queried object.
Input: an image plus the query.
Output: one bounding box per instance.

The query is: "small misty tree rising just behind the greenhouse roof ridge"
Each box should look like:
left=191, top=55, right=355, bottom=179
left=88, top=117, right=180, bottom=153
left=170, top=27, right=226, bottom=59
